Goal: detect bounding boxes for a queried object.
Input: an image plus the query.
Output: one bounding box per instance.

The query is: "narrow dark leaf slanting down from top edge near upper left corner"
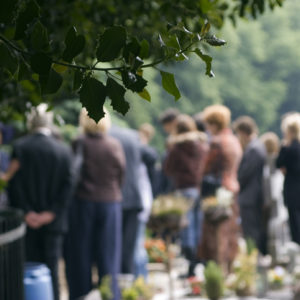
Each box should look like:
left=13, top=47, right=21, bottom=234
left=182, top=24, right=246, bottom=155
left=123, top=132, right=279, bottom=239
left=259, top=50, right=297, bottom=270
left=15, top=0, right=40, bottom=40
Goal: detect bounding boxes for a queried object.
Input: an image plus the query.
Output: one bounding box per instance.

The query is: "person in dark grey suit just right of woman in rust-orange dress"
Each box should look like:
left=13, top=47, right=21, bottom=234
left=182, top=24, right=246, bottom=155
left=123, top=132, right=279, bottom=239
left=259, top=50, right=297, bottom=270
left=233, top=116, right=267, bottom=255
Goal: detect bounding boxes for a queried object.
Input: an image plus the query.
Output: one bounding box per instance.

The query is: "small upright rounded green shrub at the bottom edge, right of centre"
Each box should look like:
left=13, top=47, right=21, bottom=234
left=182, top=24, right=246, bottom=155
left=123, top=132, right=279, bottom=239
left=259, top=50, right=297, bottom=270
left=204, top=261, right=224, bottom=300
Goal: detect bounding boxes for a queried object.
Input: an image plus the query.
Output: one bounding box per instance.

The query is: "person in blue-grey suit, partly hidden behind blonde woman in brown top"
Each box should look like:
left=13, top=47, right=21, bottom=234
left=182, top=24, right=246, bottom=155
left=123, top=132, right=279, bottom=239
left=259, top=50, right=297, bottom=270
left=110, top=126, right=143, bottom=274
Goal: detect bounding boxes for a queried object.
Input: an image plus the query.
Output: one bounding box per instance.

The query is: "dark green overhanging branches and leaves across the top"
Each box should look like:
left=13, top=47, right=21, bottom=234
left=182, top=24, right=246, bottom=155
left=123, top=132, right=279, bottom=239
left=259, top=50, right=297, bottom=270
left=0, top=0, right=283, bottom=120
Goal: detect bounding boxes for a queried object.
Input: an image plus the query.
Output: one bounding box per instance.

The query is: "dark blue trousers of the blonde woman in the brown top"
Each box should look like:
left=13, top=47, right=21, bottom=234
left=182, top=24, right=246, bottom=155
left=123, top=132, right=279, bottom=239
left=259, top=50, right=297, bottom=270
left=66, top=199, right=122, bottom=300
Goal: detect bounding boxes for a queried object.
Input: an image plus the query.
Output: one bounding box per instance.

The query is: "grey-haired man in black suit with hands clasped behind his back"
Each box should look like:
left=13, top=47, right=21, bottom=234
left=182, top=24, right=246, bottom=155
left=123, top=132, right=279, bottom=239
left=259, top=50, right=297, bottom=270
left=9, top=105, right=72, bottom=300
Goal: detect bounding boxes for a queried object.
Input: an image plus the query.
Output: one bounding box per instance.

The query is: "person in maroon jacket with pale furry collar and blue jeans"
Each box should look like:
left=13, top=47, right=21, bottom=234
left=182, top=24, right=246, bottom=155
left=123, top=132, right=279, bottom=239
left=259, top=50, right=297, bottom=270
left=164, top=115, right=208, bottom=277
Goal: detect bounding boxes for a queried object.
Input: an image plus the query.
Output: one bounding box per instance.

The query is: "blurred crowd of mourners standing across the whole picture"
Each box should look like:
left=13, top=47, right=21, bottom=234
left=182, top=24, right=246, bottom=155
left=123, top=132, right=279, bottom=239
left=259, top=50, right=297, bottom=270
left=0, top=105, right=300, bottom=300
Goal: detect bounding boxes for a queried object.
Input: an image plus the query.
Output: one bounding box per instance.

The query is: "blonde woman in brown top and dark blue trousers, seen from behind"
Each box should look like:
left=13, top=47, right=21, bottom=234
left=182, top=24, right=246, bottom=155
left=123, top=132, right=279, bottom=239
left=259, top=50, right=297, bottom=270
left=66, top=109, right=125, bottom=300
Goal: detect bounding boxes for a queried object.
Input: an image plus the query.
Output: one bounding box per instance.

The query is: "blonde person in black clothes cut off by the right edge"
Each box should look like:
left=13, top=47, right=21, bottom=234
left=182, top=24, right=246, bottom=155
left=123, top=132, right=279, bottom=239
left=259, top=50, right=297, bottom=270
left=276, top=113, right=300, bottom=244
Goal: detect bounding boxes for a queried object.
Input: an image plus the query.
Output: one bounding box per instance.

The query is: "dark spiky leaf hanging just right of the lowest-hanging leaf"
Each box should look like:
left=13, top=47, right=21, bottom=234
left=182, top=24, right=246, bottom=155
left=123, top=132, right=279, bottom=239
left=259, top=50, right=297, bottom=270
left=106, top=77, right=129, bottom=115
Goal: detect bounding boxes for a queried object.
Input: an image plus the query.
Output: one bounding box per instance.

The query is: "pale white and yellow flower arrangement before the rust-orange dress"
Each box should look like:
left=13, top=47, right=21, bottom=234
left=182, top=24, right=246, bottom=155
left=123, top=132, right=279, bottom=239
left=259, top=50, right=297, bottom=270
left=202, top=187, right=233, bottom=224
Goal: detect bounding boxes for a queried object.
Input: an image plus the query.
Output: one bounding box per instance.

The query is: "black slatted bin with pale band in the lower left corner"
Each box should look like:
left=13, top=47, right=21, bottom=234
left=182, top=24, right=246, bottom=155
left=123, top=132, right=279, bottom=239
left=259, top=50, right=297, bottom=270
left=0, top=208, right=26, bottom=300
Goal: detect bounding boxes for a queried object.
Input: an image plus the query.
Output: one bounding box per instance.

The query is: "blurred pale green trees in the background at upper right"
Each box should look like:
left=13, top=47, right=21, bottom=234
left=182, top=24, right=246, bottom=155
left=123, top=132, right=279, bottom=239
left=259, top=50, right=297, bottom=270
left=106, top=0, right=300, bottom=150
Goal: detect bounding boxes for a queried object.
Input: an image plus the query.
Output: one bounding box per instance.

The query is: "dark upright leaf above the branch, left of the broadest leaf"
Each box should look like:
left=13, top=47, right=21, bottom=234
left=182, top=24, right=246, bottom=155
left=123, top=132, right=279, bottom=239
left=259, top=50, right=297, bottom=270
left=62, top=26, right=85, bottom=63
